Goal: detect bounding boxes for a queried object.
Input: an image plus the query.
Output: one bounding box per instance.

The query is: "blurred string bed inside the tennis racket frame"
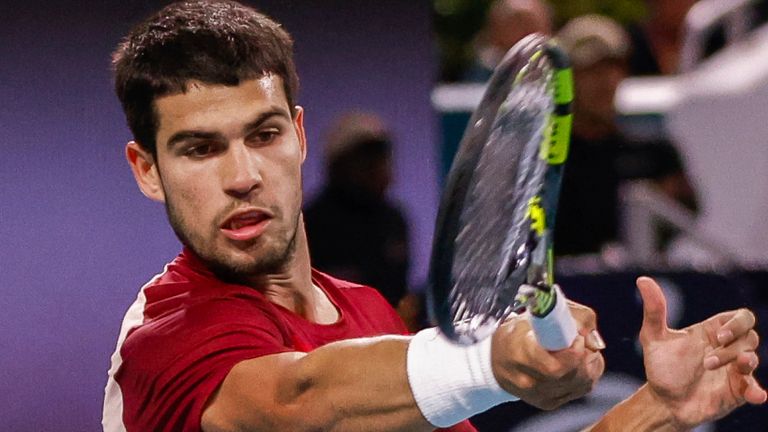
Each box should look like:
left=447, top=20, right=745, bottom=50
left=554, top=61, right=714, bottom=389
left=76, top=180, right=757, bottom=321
left=450, top=61, right=553, bottom=332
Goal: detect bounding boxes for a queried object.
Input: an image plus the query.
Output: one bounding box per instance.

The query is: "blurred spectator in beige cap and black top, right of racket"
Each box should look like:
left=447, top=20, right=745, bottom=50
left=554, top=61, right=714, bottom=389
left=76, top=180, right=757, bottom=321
left=555, top=15, right=696, bottom=255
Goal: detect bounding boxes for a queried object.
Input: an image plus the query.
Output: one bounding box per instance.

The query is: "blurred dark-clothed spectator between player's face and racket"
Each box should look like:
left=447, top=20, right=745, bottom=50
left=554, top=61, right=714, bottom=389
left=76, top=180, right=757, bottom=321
left=304, top=112, right=419, bottom=330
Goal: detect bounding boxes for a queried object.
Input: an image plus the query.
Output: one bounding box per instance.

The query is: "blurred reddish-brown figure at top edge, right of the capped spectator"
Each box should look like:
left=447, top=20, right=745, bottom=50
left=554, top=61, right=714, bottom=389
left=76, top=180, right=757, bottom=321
left=629, top=0, right=696, bottom=75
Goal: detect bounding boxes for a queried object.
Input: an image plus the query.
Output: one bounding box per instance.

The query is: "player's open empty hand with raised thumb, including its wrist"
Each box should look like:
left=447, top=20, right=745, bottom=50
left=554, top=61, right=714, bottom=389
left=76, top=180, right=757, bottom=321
left=587, top=278, right=766, bottom=432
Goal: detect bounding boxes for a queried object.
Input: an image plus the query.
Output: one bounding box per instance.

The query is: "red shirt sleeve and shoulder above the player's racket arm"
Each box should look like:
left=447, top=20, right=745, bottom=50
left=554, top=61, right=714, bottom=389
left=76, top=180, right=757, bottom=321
left=113, top=282, right=294, bottom=430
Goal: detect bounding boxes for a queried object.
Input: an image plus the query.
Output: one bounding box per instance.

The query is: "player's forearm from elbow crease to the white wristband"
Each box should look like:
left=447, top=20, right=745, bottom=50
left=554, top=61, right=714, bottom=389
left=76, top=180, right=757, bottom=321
left=280, top=337, right=434, bottom=431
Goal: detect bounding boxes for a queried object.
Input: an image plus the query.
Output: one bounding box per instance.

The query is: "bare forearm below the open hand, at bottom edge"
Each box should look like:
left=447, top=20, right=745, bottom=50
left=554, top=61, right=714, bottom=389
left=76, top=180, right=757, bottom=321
left=583, top=384, right=688, bottom=432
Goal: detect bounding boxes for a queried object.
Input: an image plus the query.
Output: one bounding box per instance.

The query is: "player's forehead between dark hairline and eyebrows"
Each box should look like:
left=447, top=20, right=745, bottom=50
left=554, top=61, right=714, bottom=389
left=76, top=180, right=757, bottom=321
left=155, top=75, right=290, bottom=143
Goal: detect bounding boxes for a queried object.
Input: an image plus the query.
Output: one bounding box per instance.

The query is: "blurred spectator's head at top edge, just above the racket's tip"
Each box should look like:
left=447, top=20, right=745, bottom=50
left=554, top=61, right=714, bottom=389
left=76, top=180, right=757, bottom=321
left=463, top=0, right=552, bottom=82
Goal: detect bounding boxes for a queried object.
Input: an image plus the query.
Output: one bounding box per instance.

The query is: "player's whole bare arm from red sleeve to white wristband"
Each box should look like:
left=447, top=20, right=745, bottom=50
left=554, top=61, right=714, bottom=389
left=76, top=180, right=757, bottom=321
left=203, top=336, right=435, bottom=431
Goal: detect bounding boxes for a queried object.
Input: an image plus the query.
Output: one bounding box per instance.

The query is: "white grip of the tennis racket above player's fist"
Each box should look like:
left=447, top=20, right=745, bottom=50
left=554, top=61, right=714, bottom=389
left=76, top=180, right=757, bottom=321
left=530, top=285, right=578, bottom=351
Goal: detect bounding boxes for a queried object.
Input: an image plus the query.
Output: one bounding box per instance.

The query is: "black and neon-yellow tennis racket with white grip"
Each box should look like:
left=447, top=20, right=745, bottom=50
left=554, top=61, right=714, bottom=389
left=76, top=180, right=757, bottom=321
left=427, top=35, right=577, bottom=351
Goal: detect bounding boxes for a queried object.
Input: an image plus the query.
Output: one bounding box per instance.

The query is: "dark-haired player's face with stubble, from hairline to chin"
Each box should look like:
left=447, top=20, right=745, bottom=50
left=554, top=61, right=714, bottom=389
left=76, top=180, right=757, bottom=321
left=148, top=75, right=306, bottom=279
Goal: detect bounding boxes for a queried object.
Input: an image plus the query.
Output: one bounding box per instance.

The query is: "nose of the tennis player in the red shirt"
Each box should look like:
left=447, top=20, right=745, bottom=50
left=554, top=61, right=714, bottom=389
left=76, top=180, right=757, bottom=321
left=222, top=141, right=262, bottom=198
